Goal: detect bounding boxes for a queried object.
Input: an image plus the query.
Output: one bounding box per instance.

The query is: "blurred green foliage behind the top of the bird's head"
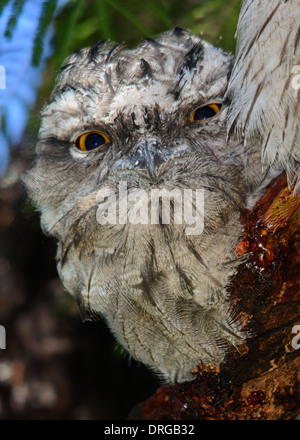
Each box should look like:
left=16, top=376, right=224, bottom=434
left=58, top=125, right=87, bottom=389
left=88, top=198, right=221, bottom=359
left=0, top=0, right=241, bottom=131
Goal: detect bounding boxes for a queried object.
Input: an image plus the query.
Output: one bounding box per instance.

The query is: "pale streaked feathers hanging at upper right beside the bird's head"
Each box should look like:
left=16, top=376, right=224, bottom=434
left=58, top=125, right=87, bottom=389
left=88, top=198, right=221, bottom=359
left=227, top=0, right=300, bottom=192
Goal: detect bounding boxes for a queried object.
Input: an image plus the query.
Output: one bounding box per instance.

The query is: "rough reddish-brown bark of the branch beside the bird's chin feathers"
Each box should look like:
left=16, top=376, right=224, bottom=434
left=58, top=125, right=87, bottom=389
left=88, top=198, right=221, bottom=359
left=129, top=176, right=300, bottom=420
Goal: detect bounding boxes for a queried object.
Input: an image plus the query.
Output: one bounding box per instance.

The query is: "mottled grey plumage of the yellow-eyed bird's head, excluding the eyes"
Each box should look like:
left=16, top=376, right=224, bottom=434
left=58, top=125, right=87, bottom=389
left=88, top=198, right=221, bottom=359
left=25, top=1, right=298, bottom=381
